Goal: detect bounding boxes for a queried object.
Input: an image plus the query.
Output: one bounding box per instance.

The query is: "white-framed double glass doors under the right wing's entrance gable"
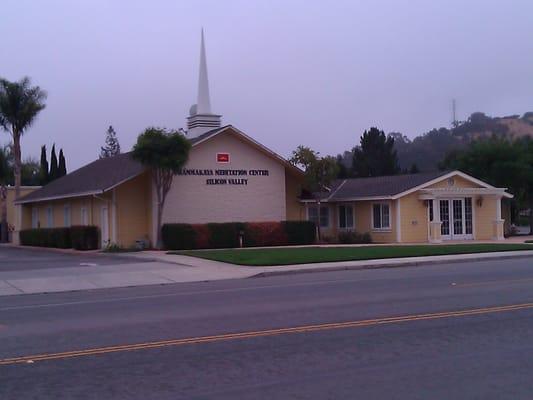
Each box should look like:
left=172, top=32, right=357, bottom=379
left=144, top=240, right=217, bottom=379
left=439, top=197, right=473, bottom=240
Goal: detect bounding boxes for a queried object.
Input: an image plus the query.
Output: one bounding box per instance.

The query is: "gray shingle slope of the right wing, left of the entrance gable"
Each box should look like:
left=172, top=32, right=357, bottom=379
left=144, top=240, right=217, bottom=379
left=315, top=171, right=450, bottom=201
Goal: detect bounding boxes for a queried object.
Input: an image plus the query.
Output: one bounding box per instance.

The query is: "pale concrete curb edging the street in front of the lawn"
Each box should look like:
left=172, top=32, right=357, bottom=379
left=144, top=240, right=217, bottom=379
left=248, top=254, right=533, bottom=279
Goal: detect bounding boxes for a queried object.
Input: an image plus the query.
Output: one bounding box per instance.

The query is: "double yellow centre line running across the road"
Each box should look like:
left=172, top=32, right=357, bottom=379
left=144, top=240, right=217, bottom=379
left=0, top=303, right=533, bottom=365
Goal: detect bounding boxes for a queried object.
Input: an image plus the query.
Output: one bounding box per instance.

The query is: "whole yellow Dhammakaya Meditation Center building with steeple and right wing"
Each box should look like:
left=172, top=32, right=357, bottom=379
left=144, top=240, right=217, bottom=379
left=14, top=34, right=512, bottom=247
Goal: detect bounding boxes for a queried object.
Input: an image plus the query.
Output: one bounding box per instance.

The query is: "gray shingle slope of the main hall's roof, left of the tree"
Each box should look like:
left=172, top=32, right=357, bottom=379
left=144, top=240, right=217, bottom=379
left=18, top=153, right=145, bottom=203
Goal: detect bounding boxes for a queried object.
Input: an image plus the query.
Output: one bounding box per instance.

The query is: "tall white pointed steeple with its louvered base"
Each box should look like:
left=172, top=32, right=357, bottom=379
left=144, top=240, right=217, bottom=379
left=187, top=29, right=221, bottom=138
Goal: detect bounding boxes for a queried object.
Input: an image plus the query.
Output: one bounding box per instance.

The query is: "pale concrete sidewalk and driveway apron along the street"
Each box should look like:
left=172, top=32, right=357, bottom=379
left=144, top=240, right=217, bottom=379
left=0, top=247, right=533, bottom=296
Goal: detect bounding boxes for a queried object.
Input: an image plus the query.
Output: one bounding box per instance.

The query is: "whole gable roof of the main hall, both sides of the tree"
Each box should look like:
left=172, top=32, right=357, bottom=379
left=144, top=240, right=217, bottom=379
left=15, top=125, right=303, bottom=204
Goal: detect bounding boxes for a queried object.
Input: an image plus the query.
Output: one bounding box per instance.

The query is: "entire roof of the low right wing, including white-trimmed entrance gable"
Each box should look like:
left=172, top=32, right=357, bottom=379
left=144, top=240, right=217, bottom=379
left=304, top=171, right=512, bottom=202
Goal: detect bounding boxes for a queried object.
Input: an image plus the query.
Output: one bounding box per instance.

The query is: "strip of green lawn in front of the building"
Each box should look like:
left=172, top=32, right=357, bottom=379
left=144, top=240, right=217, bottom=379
left=174, top=243, right=533, bottom=266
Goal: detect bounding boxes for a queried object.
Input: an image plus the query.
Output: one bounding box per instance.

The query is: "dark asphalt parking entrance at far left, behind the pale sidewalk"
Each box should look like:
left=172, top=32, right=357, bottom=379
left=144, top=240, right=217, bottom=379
left=0, top=246, right=147, bottom=272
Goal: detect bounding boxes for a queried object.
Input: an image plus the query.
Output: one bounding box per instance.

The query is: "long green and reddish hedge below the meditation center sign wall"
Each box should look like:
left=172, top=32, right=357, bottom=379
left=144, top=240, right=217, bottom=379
left=161, top=221, right=316, bottom=250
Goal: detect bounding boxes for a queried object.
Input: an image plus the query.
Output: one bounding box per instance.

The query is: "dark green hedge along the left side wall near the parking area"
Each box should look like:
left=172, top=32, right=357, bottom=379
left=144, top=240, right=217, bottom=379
left=20, top=226, right=99, bottom=250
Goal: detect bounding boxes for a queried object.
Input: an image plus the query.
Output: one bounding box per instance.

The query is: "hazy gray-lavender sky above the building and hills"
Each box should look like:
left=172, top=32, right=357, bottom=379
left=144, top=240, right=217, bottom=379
left=0, top=0, right=533, bottom=171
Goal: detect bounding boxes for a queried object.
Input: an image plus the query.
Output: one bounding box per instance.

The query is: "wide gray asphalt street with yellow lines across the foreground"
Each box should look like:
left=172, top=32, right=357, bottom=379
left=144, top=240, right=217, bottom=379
left=0, top=255, right=533, bottom=400
